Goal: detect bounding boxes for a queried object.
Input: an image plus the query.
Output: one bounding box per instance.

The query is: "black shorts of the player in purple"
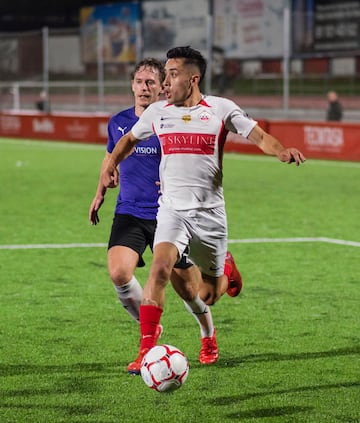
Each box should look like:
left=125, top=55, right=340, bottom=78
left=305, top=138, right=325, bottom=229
left=108, top=214, right=193, bottom=269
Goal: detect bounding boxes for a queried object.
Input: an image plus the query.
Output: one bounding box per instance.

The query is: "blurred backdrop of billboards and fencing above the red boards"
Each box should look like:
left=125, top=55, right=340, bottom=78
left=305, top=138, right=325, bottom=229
left=0, top=0, right=360, bottom=120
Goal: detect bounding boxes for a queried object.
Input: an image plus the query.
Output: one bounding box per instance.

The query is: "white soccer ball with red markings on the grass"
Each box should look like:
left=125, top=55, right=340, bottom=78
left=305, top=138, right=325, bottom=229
left=140, top=345, right=189, bottom=392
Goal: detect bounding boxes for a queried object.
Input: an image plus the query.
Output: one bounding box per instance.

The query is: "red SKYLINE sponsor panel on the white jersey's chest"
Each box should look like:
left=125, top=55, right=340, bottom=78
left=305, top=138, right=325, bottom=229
left=159, top=132, right=216, bottom=154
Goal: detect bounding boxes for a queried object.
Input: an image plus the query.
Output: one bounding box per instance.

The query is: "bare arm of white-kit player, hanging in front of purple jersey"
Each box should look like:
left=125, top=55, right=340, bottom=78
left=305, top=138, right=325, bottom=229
left=100, top=131, right=139, bottom=188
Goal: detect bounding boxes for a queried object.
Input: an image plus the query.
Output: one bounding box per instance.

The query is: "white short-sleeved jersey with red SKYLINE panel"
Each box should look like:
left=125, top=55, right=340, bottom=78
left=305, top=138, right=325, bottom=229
left=131, top=96, right=257, bottom=210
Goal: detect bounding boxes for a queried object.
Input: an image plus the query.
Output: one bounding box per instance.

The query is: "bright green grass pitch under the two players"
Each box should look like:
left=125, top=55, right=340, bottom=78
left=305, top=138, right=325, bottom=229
left=0, top=139, right=360, bottom=423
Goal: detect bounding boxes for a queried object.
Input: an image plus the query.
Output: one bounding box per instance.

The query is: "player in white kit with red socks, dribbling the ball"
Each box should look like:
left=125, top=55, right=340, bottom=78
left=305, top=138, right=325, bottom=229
left=102, top=47, right=305, bottom=371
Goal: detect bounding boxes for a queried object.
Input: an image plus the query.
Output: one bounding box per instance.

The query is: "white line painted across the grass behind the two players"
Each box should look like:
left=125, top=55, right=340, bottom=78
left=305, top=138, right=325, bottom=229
left=0, top=237, right=360, bottom=250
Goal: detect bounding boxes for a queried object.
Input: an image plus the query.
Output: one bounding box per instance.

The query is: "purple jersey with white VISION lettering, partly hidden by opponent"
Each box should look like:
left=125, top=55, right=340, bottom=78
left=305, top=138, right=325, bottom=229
left=107, top=107, right=161, bottom=219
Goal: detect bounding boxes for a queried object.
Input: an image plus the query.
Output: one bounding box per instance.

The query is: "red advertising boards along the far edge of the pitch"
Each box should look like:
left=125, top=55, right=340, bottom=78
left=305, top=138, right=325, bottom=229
left=0, top=112, right=360, bottom=161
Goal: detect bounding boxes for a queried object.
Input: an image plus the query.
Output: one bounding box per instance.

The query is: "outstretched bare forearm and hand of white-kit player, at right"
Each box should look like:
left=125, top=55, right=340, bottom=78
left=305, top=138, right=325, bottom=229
left=248, top=125, right=306, bottom=166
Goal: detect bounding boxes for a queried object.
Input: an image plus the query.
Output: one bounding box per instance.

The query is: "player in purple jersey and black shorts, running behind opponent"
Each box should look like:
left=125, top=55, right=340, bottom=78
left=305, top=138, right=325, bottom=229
left=89, top=58, right=241, bottom=374
